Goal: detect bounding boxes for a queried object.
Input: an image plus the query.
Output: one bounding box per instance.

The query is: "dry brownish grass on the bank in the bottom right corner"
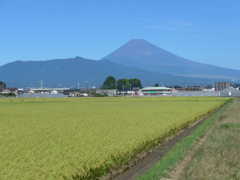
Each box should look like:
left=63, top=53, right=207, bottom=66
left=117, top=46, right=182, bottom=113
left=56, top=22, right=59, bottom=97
left=179, top=99, right=240, bottom=180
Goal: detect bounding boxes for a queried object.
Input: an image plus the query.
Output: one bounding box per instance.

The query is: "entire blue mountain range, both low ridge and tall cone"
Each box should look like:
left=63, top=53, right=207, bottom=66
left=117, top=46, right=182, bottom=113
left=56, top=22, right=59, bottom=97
left=0, top=39, right=240, bottom=88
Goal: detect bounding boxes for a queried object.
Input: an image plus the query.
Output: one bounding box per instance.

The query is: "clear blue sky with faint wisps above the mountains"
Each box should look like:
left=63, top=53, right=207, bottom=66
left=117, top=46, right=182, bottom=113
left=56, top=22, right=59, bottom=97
left=0, top=0, right=240, bottom=70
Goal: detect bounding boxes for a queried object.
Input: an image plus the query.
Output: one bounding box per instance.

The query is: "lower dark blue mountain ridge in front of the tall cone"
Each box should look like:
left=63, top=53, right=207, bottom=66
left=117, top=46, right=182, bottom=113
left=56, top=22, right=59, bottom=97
left=0, top=57, right=223, bottom=88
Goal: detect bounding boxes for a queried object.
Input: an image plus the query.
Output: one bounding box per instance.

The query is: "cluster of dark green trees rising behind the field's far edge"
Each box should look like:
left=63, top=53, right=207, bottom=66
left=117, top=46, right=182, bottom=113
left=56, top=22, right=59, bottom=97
left=101, top=76, right=143, bottom=90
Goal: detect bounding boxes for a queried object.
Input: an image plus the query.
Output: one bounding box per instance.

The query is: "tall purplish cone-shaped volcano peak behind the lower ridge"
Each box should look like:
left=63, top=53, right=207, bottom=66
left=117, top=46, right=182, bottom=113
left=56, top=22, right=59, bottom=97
left=101, top=39, right=240, bottom=79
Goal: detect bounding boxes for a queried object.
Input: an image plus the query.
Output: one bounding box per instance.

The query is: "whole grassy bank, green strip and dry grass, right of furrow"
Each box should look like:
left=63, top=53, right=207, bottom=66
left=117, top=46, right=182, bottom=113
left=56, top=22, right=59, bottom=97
left=138, top=99, right=236, bottom=180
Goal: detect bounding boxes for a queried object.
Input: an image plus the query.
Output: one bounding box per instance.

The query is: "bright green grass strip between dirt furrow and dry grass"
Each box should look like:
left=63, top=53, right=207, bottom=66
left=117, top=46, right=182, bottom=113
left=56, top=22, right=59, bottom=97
left=137, top=101, right=233, bottom=180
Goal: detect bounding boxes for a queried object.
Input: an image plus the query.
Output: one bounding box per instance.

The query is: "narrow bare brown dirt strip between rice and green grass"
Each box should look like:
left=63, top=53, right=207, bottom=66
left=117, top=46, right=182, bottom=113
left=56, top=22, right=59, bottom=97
left=113, top=107, right=225, bottom=180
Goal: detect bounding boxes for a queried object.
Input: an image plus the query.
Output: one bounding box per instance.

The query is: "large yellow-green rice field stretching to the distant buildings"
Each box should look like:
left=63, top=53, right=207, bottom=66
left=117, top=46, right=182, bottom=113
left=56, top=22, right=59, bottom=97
left=0, top=97, right=229, bottom=179
